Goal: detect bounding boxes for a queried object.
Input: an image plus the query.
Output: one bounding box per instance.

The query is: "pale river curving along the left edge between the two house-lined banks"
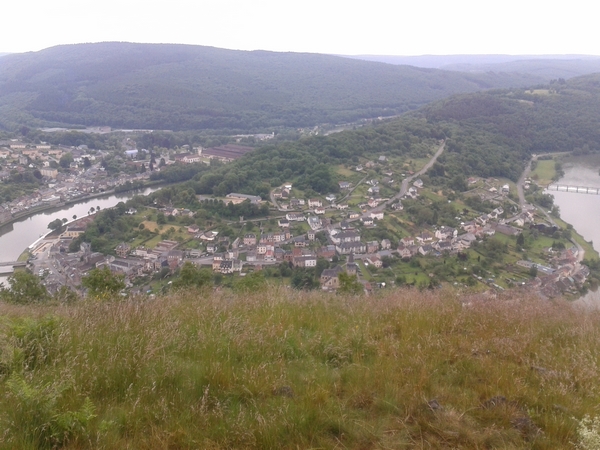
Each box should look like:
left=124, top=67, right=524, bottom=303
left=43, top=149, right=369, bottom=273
left=0, top=187, right=160, bottom=285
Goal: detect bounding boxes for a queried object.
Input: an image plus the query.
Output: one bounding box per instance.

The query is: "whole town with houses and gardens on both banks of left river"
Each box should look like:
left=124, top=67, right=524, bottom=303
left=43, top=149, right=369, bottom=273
left=0, top=135, right=589, bottom=297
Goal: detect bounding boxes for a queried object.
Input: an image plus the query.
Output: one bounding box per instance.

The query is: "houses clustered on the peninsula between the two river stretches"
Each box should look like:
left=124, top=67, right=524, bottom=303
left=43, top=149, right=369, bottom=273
left=23, top=160, right=589, bottom=297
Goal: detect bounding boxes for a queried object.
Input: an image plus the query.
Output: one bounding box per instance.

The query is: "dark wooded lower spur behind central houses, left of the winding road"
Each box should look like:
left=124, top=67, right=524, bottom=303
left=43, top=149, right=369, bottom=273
left=193, top=119, right=445, bottom=198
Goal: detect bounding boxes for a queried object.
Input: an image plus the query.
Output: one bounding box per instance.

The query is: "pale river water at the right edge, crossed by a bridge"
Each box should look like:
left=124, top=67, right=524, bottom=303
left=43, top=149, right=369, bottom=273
left=546, top=155, right=600, bottom=307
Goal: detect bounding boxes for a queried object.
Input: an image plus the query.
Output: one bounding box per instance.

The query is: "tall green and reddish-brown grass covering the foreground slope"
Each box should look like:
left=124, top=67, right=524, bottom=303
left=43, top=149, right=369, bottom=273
left=0, top=288, right=600, bottom=449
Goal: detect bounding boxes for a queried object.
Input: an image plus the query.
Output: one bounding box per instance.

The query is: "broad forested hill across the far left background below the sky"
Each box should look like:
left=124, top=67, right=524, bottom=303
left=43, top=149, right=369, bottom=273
left=0, top=42, right=540, bottom=131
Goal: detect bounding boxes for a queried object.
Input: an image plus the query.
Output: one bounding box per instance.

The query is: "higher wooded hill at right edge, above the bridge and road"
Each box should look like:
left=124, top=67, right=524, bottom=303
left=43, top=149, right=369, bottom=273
left=412, top=74, right=600, bottom=180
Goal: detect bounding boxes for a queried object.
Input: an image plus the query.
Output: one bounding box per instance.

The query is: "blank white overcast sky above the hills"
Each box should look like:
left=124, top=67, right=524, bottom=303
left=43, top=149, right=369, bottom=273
left=0, top=0, right=600, bottom=56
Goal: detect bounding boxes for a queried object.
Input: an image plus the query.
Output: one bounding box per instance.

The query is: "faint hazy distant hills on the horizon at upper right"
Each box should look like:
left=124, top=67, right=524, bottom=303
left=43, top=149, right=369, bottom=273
left=348, top=55, right=600, bottom=81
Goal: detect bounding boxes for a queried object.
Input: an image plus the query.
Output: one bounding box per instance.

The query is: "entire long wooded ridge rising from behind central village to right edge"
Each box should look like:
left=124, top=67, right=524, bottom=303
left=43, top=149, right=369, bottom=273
left=156, top=74, right=600, bottom=198
